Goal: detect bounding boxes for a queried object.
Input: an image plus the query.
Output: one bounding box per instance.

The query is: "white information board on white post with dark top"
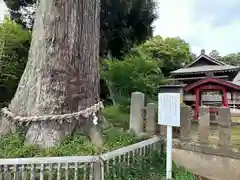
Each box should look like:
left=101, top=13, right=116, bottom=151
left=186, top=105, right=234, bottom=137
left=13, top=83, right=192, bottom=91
left=158, top=86, right=181, bottom=179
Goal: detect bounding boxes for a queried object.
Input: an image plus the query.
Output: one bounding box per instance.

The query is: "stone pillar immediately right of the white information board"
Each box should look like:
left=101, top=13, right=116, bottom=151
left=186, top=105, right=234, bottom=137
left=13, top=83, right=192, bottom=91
left=180, top=104, right=192, bottom=141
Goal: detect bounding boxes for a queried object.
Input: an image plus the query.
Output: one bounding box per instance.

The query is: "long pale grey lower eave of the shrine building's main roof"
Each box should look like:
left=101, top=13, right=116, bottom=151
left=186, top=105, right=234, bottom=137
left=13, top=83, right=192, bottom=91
left=171, top=65, right=240, bottom=74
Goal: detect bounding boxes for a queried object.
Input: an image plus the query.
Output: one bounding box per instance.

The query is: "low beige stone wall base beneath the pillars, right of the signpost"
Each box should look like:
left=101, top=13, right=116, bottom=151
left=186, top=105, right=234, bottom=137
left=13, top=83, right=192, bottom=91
left=173, top=148, right=240, bottom=180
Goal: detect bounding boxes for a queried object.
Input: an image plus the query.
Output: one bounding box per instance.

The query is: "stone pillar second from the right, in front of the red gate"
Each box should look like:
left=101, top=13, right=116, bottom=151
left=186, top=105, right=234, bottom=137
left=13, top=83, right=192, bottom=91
left=198, top=107, right=210, bottom=144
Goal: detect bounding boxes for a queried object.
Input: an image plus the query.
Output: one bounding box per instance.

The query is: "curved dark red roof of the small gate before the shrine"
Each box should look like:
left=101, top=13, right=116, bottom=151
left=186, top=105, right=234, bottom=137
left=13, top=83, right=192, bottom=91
left=185, top=77, right=240, bottom=91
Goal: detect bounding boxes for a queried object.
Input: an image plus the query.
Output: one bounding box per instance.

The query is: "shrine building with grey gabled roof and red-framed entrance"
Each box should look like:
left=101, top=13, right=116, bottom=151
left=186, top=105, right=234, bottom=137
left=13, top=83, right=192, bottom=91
left=171, top=50, right=240, bottom=119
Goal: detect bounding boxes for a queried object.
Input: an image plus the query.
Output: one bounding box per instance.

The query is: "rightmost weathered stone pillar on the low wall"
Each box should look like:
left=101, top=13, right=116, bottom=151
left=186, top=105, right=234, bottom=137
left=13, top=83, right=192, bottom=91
left=218, top=107, right=232, bottom=147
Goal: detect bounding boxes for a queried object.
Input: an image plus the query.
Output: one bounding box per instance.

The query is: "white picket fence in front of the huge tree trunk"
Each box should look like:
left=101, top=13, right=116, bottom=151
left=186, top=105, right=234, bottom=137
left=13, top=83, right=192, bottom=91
left=0, top=136, right=162, bottom=180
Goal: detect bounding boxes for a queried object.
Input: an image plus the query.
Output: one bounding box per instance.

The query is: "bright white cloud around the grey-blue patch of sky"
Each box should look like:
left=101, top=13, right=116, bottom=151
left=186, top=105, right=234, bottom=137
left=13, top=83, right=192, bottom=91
left=154, top=0, right=240, bottom=55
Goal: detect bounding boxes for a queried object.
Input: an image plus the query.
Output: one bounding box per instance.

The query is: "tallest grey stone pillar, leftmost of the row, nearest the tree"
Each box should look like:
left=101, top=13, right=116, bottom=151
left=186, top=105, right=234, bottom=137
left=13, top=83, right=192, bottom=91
left=129, top=92, right=145, bottom=135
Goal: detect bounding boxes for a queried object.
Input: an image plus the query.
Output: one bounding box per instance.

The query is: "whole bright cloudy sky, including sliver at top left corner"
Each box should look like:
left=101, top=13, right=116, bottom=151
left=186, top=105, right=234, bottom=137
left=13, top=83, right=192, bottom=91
left=0, top=0, right=240, bottom=55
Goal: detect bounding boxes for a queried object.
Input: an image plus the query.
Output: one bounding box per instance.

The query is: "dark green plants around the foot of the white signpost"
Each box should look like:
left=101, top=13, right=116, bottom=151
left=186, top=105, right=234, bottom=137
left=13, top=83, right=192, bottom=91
left=105, top=151, right=196, bottom=180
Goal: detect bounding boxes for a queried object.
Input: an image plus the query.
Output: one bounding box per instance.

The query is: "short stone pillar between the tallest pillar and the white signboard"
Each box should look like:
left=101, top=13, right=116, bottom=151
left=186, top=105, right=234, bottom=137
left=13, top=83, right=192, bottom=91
left=145, top=103, right=156, bottom=135
